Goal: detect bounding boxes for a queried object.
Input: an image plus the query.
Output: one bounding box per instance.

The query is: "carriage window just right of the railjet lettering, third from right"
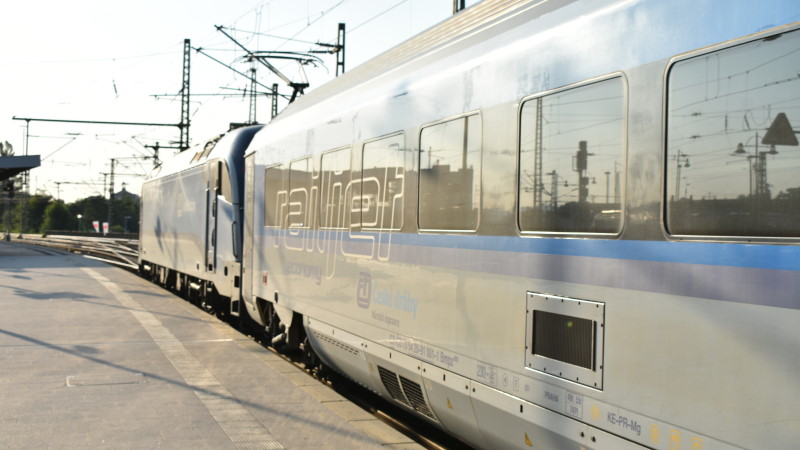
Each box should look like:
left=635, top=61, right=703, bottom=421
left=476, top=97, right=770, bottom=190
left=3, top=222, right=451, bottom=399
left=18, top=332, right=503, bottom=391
left=419, top=114, right=481, bottom=231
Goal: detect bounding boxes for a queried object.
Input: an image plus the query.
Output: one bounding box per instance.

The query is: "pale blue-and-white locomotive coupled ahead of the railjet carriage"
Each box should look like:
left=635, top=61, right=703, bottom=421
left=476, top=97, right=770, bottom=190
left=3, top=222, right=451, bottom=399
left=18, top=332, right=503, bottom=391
left=139, top=126, right=261, bottom=315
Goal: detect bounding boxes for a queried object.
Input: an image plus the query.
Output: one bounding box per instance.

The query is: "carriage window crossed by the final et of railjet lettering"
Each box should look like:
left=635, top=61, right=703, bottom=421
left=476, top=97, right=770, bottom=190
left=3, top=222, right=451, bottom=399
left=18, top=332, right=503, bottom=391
left=360, top=134, right=408, bottom=230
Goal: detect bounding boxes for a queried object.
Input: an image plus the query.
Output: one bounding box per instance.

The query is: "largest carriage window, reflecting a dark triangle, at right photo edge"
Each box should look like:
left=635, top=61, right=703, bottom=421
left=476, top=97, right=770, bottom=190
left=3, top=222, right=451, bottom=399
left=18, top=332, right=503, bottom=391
left=665, top=31, right=800, bottom=237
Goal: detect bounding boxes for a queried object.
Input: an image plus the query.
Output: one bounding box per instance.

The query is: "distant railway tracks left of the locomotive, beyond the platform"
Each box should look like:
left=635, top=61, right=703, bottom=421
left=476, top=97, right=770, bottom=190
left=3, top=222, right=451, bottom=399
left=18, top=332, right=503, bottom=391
left=13, top=234, right=139, bottom=270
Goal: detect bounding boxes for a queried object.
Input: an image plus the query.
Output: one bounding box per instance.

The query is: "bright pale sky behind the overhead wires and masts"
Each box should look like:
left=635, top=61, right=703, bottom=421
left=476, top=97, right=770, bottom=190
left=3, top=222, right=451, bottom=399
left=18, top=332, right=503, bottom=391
left=0, top=0, right=478, bottom=202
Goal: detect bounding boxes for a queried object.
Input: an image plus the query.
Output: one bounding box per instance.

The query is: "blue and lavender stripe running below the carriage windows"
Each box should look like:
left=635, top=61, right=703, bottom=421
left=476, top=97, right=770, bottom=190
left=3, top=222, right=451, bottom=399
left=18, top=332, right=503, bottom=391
left=266, top=230, right=800, bottom=309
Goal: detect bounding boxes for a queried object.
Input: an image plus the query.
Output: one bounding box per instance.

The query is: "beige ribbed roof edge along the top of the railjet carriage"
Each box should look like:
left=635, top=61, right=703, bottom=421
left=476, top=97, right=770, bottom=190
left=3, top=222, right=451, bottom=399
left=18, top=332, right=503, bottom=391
left=273, top=0, right=577, bottom=122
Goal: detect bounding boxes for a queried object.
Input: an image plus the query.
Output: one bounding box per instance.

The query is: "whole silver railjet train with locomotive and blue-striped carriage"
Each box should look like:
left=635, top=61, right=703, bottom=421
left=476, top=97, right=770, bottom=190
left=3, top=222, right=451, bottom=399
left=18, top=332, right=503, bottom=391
left=141, top=0, right=800, bottom=450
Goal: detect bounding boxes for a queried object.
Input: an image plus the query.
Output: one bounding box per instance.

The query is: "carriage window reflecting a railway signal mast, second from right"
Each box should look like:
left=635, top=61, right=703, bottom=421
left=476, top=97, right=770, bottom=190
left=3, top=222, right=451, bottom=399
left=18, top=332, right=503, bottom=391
left=518, top=77, right=625, bottom=233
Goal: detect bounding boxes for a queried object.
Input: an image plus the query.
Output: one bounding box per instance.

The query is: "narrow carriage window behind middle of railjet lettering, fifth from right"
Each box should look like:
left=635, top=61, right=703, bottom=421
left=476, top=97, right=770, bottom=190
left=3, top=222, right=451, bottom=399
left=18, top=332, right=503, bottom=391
left=320, top=148, right=350, bottom=229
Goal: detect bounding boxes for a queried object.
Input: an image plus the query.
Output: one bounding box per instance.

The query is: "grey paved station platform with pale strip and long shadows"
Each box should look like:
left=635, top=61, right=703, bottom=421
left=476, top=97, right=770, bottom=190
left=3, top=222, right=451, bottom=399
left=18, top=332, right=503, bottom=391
left=0, top=242, right=420, bottom=449
